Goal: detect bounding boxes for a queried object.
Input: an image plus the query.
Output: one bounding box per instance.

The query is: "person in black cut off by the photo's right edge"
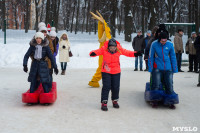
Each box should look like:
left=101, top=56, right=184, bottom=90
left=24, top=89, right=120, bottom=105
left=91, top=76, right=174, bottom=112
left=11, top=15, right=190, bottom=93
left=194, top=32, right=200, bottom=87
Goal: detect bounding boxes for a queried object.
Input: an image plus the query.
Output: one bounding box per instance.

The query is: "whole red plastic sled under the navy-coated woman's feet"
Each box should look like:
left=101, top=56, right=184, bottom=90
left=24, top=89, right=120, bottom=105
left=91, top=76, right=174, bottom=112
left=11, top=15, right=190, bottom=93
left=22, top=82, right=57, bottom=104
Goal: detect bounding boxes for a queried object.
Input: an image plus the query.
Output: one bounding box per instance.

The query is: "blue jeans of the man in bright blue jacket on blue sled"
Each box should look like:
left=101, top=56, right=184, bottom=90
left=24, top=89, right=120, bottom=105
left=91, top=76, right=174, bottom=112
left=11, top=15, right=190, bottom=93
left=151, top=68, right=174, bottom=94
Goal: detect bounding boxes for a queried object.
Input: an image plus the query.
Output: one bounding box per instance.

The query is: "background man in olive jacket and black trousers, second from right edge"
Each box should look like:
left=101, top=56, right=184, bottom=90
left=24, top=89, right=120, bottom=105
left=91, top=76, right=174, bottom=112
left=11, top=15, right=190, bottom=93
left=185, top=32, right=198, bottom=73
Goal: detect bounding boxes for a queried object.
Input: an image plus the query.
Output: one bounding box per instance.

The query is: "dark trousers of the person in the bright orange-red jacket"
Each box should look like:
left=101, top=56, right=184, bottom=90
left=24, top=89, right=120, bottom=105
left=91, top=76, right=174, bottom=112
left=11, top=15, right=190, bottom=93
left=101, top=72, right=121, bottom=102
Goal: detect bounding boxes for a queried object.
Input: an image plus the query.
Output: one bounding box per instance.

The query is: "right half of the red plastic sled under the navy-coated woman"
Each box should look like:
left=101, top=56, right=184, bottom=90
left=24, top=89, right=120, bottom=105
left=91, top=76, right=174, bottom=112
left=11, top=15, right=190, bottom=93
left=39, top=82, right=57, bottom=104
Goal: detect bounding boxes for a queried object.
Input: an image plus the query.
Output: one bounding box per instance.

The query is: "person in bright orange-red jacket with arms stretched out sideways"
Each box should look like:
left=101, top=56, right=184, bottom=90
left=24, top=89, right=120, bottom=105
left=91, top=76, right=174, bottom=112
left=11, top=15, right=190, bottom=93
left=90, top=39, right=141, bottom=111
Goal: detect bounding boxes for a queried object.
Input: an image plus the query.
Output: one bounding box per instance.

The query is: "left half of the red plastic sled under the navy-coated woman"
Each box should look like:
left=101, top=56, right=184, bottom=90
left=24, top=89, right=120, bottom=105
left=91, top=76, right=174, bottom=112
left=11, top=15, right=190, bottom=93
left=22, top=84, right=43, bottom=103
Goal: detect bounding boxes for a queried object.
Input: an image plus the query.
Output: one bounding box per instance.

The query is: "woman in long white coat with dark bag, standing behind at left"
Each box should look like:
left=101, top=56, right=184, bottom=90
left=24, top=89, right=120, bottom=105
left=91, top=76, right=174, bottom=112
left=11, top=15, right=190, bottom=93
left=59, top=33, right=70, bottom=75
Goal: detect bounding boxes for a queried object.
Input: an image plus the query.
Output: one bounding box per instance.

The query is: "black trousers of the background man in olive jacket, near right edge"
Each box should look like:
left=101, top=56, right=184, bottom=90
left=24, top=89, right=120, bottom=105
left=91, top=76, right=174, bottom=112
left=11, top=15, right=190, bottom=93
left=189, top=54, right=198, bottom=71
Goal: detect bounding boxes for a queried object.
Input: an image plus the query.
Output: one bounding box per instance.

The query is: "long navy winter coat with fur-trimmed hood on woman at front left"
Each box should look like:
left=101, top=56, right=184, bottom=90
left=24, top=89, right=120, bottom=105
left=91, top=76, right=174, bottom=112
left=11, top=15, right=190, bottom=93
left=23, top=38, right=57, bottom=83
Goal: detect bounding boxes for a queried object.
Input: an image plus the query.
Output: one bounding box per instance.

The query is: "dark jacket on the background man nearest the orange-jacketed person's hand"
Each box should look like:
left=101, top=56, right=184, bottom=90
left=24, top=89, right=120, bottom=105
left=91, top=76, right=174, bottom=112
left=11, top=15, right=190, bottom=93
left=132, top=35, right=145, bottom=53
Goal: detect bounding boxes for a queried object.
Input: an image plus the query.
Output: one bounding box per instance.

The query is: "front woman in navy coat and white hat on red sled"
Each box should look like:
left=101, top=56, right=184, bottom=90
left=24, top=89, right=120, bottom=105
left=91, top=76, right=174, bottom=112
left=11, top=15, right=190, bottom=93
left=23, top=32, right=58, bottom=93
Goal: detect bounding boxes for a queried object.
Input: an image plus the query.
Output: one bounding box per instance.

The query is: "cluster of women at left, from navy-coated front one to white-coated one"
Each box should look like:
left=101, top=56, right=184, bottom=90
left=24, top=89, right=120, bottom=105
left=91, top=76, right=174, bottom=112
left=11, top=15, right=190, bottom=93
left=23, top=22, right=70, bottom=93
